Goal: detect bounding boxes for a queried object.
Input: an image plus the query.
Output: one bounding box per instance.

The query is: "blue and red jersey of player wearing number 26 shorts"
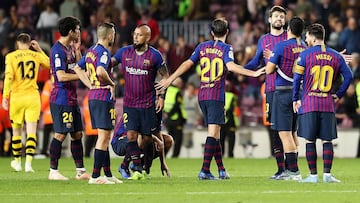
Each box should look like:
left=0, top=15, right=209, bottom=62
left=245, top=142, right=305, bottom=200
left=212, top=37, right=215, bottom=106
left=50, top=41, right=77, bottom=106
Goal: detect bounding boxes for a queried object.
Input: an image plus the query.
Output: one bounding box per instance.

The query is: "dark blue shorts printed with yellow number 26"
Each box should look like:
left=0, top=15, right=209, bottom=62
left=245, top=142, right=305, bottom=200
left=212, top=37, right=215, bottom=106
left=50, top=103, right=83, bottom=134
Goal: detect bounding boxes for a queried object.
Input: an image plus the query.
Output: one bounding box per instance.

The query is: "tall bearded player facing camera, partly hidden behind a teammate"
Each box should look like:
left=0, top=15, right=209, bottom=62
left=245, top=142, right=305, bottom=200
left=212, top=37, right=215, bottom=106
left=245, top=6, right=287, bottom=179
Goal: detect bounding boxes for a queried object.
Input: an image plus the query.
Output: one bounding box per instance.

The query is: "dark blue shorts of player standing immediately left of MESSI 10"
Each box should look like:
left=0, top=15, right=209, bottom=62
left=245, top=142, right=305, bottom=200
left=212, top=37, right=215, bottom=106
left=271, top=90, right=297, bottom=132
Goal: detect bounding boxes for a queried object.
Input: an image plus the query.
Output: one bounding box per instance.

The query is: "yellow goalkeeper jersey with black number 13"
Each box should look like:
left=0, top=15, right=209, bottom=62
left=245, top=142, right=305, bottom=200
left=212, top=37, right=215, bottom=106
left=3, top=49, right=50, bottom=98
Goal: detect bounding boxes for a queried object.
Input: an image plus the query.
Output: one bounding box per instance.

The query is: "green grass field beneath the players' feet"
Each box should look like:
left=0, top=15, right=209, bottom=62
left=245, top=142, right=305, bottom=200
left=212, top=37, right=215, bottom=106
left=0, top=158, right=360, bottom=203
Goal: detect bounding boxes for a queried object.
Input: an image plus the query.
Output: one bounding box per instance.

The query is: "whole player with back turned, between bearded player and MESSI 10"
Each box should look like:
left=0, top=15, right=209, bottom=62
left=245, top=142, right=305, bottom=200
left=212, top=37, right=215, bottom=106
left=266, top=17, right=306, bottom=180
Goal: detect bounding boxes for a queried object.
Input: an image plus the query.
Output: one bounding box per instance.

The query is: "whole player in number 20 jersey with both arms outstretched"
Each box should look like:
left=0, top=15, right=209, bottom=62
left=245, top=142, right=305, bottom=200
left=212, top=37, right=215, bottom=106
left=156, top=19, right=264, bottom=180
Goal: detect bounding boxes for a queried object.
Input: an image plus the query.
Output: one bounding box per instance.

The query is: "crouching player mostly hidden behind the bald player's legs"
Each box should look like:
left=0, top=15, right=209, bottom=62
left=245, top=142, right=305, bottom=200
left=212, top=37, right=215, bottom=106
left=111, top=116, right=174, bottom=179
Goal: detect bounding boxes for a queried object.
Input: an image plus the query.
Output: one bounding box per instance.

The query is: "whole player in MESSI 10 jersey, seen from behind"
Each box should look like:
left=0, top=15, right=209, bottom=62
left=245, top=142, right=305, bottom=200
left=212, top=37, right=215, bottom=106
left=293, top=24, right=352, bottom=183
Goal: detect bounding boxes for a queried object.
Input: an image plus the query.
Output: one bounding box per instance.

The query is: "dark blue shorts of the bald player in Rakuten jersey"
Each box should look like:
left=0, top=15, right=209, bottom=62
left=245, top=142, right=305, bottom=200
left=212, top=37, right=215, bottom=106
left=123, top=107, right=158, bottom=136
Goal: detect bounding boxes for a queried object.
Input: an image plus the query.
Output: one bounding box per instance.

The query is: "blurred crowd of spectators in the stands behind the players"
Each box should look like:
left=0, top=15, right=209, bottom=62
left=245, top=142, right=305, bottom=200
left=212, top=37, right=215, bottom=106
left=0, top=0, right=360, bottom=156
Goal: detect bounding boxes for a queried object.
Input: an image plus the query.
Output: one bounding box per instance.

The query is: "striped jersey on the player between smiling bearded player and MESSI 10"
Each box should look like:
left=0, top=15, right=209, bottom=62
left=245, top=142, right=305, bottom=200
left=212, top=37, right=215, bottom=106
left=269, top=38, right=306, bottom=86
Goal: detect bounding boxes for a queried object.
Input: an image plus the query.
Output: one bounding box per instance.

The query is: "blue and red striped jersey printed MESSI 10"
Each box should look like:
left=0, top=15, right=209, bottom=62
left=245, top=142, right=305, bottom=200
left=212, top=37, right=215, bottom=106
left=293, top=45, right=353, bottom=114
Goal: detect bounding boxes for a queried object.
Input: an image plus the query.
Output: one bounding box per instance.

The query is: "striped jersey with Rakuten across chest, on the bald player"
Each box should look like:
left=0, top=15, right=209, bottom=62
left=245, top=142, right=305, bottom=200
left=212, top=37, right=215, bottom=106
left=114, top=45, right=165, bottom=108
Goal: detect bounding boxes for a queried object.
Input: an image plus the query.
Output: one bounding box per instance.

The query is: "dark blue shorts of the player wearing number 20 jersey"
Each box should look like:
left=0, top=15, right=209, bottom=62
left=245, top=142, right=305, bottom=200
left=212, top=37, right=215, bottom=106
left=199, top=100, right=225, bottom=125
